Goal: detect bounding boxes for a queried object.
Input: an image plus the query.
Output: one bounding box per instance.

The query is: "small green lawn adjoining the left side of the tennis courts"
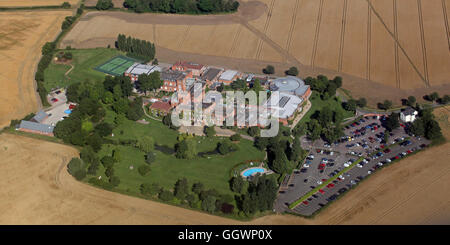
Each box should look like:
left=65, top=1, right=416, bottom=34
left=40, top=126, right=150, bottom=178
left=44, top=48, right=123, bottom=90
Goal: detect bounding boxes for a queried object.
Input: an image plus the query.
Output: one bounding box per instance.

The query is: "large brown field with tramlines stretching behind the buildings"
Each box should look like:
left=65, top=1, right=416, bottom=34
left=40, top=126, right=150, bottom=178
left=62, top=0, right=450, bottom=105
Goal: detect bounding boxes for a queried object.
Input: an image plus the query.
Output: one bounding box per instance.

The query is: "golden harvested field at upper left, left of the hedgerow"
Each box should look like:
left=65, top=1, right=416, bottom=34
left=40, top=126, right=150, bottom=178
left=0, top=11, right=71, bottom=128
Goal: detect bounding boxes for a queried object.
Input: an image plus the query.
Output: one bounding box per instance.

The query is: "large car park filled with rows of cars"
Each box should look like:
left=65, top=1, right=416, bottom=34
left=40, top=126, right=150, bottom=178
left=275, top=117, right=429, bottom=216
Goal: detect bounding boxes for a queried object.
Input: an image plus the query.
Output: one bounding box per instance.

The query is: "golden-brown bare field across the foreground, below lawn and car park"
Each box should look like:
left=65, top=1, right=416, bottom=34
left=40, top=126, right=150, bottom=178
left=0, top=109, right=450, bottom=224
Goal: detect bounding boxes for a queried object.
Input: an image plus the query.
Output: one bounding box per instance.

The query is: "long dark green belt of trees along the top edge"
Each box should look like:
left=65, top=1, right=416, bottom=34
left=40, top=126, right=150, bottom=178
left=124, top=0, right=239, bottom=14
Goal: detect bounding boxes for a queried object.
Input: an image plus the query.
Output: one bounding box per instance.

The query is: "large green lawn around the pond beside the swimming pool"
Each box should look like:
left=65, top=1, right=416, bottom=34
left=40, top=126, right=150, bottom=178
left=97, top=120, right=264, bottom=194
